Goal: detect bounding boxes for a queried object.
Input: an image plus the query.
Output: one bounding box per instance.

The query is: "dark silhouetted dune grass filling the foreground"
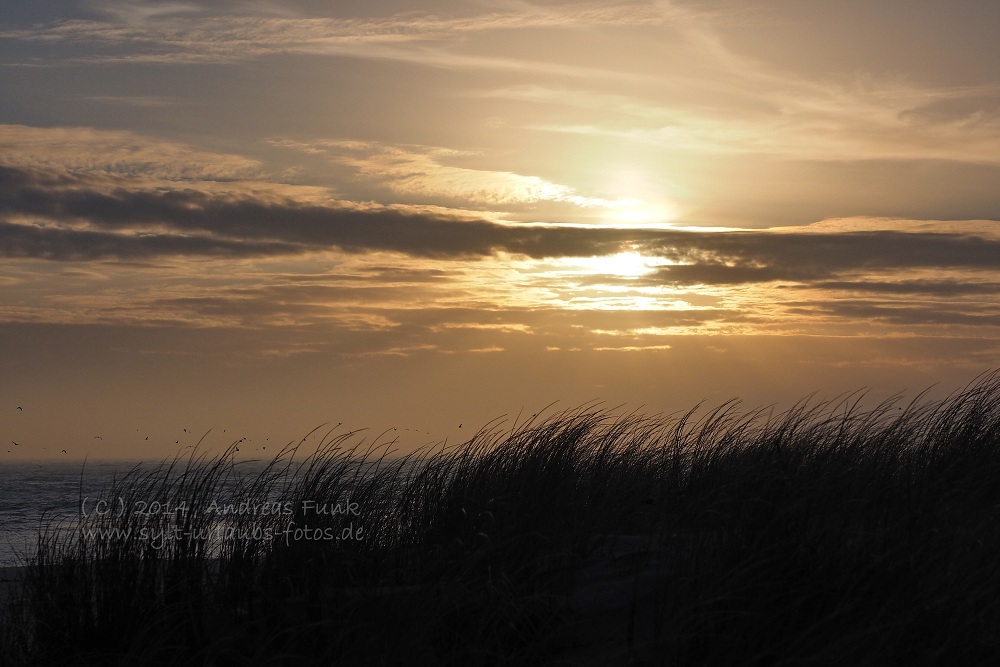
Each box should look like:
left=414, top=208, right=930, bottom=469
left=0, top=373, right=1000, bottom=667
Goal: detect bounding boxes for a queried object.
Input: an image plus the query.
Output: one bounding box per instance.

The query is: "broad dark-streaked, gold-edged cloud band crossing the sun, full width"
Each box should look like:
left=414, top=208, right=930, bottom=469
left=0, top=127, right=1000, bottom=344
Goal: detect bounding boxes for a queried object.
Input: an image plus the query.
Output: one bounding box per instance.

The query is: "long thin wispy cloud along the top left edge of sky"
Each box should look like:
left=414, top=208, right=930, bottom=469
left=0, top=3, right=670, bottom=63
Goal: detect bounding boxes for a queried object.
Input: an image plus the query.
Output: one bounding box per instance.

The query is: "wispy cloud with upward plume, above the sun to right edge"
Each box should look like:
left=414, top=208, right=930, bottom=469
left=467, top=27, right=1000, bottom=164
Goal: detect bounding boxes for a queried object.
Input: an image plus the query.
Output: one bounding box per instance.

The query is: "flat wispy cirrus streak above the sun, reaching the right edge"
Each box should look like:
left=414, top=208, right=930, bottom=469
left=516, top=80, right=1000, bottom=164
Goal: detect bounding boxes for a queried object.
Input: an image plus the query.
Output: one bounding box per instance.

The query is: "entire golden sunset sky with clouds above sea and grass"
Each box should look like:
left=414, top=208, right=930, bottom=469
left=0, top=0, right=1000, bottom=460
